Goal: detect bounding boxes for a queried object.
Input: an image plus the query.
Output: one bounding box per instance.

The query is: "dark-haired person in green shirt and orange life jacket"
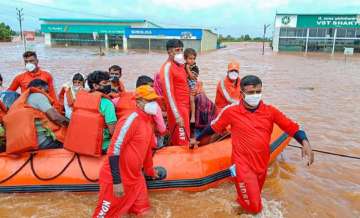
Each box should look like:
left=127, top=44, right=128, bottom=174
left=65, top=71, right=117, bottom=153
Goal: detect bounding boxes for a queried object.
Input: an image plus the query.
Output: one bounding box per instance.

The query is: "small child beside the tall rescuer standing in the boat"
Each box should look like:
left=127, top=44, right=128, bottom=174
left=184, top=48, right=199, bottom=126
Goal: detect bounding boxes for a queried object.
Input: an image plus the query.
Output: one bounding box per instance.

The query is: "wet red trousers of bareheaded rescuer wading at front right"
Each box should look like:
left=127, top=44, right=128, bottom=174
left=234, top=163, right=266, bottom=213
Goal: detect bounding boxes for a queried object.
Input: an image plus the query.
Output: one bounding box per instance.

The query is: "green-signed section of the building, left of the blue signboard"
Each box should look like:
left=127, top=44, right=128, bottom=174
left=40, top=18, right=159, bottom=48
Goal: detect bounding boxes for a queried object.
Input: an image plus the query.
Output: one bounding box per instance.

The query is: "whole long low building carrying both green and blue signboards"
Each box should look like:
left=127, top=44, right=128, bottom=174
left=40, top=18, right=217, bottom=51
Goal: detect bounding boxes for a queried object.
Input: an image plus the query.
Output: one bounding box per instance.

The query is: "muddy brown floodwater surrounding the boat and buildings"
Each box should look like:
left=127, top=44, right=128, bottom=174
left=0, top=39, right=360, bottom=217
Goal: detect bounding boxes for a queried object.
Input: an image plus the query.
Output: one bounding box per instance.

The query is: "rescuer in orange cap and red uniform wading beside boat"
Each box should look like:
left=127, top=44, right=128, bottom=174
left=93, top=85, right=165, bottom=217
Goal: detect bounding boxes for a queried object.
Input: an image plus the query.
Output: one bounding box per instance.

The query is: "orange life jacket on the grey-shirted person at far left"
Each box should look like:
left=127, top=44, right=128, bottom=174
left=3, top=88, right=66, bottom=153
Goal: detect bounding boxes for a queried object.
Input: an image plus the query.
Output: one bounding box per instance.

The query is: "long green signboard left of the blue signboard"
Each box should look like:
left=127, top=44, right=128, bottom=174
left=41, top=24, right=127, bottom=34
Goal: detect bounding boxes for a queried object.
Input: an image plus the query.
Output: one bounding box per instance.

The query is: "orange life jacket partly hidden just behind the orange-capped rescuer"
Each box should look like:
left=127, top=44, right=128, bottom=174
left=115, top=92, right=136, bottom=119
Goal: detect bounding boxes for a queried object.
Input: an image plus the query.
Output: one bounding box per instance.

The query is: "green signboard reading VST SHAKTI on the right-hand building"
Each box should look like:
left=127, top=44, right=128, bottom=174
left=297, top=15, right=360, bottom=28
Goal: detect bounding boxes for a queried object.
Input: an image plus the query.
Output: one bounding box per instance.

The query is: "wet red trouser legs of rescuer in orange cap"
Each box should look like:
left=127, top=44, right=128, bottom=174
left=93, top=177, right=150, bottom=218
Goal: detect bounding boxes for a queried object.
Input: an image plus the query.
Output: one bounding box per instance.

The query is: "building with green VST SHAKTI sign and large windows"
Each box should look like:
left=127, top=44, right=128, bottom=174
left=272, top=14, right=360, bottom=53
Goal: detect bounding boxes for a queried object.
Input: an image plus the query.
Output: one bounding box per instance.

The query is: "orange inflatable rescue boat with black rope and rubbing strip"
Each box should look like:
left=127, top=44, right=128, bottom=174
left=0, top=126, right=290, bottom=193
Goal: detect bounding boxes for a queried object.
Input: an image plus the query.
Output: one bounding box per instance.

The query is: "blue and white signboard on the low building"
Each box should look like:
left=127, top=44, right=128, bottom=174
left=125, top=28, right=202, bottom=40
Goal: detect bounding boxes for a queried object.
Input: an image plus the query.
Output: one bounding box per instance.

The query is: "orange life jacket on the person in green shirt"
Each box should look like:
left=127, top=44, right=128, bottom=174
left=64, top=90, right=107, bottom=157
